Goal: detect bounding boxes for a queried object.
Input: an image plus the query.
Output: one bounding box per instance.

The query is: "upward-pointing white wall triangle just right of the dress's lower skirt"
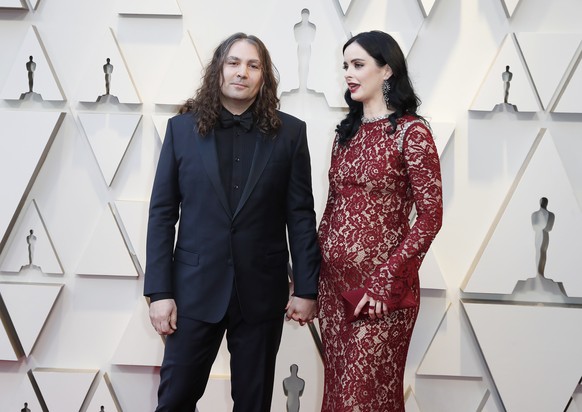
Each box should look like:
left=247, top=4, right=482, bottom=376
left=417, top=306, right=483, bottom=378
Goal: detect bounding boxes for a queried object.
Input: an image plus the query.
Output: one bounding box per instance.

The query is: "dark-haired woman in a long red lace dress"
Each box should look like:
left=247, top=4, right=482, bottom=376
left=318, top=31, right=442, bottom=412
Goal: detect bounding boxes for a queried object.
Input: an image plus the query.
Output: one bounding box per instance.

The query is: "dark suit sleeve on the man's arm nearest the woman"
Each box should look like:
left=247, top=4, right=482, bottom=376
left=287, top=122, right=321, bottom=297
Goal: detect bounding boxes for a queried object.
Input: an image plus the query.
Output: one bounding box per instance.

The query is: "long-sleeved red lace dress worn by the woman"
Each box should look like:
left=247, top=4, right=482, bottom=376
left=318, top=116, right=442, bottom=412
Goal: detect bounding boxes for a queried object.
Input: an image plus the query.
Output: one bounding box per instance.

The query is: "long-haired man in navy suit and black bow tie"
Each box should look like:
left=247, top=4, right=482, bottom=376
left=144, top=33, right=320, bottom=412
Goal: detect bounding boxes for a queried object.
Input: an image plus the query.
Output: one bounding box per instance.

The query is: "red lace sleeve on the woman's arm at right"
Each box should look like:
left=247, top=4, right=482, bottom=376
left=366, top=121, right=443, bottom=302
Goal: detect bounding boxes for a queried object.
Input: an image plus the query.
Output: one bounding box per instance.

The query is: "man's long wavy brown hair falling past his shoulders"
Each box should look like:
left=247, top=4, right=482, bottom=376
left=180, top=33, right=281, bottom=136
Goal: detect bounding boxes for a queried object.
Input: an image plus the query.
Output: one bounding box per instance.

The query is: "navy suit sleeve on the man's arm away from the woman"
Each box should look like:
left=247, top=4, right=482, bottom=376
left=144, top=119, right=181, bottom=296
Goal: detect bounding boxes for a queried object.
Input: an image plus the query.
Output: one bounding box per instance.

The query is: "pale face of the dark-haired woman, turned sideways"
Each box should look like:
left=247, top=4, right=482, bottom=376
left=344, top=42, right=392, bottom=104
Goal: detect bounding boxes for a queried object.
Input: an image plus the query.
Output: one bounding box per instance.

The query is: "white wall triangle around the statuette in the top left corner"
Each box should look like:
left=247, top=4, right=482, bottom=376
left=0, top=25, right=66, bottom=101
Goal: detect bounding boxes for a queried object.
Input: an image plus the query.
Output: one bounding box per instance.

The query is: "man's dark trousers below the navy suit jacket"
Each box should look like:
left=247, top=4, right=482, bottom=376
left=156, top=292, right=283, bottom=412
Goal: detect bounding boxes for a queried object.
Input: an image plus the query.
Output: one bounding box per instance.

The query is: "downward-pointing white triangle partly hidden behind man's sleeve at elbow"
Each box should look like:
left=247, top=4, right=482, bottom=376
left=114, top=200, right=149, bottom=275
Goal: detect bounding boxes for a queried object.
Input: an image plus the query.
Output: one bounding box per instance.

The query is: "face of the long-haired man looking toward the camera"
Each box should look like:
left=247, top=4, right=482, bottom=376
left=220, top=40, right=263, bottom=114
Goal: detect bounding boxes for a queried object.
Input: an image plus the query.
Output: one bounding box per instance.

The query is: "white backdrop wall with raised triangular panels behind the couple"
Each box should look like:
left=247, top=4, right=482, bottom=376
left=0, top=0, right=582, bottom=412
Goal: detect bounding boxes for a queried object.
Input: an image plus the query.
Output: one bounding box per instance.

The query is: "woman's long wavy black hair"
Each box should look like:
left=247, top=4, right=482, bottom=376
left=335, top=30, right=420, bottom=145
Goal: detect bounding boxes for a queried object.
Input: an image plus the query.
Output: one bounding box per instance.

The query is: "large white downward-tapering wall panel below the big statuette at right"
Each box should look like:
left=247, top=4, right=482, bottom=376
left=464, top=303, right=582, bottom=411
